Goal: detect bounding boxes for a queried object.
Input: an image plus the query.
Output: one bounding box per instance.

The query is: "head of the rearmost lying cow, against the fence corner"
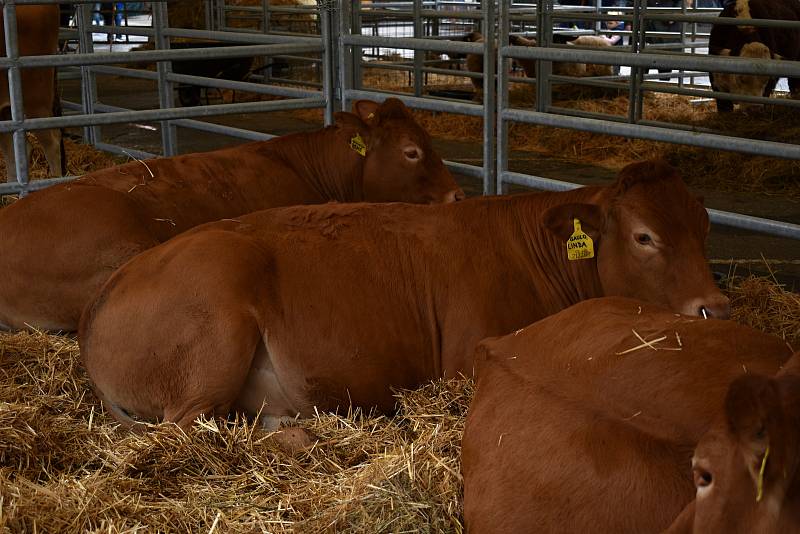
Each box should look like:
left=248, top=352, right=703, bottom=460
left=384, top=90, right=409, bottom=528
left=336, top=98, right=464, bottom=203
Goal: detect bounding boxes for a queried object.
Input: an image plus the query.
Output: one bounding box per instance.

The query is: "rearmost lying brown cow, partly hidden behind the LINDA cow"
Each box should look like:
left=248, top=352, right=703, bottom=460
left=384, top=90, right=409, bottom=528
left=0, top=99, right=464, bottom=330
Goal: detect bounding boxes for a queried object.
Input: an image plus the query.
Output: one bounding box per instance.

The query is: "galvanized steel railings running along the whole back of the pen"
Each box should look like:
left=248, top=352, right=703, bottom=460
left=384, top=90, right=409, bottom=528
left=0, top=0, right=800, bottom=239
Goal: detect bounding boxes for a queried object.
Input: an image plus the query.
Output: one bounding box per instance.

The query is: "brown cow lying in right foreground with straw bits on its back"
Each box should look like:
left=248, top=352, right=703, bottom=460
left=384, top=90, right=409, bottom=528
left=462, top=298, right=800, bottom=534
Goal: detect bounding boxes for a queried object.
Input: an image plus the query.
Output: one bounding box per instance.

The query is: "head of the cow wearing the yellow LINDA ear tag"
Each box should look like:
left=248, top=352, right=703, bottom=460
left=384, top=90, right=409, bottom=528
left=544, top=160, right=730, bottom=318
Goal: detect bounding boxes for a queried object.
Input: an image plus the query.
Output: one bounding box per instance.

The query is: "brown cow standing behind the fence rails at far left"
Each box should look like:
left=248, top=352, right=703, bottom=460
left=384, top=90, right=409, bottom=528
left=0, top=4, right=67, bottom=182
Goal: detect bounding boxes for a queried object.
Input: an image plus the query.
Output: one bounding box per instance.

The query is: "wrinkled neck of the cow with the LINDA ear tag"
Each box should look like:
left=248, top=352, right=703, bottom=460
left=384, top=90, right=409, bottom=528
left=500, top=187, right=605, bottom=316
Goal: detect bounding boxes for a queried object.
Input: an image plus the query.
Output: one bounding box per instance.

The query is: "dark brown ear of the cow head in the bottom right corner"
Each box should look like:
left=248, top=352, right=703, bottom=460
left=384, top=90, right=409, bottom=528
left=725, top=374, right=783, bottom=491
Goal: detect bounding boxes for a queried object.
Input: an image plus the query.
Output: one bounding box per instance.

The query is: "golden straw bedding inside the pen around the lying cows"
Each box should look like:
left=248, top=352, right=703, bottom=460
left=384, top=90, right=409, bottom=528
left=0, top=277, right=800, bottom=532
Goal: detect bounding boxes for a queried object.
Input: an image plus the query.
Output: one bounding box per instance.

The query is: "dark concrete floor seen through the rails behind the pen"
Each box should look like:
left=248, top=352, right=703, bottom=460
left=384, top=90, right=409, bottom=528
left=62, top=77, right=800, bottom=284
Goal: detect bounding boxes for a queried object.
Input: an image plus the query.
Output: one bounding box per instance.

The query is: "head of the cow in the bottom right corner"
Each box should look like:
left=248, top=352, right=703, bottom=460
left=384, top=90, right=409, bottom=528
left=670, top=366, right=800, bottom=534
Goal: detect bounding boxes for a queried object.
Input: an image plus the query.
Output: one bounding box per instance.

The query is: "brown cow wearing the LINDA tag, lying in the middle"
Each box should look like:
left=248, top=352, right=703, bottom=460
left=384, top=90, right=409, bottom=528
left=79, top=162, right=728, bottom=432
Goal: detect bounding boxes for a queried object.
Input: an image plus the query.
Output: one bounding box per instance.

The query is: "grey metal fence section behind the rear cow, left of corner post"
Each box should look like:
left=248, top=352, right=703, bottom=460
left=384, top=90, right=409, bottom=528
left=0, top=0, right=334, bottom=195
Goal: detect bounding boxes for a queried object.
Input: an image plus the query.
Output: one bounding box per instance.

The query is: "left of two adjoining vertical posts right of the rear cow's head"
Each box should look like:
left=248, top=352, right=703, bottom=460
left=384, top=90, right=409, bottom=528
left=481, top=0, right=494, bottom=195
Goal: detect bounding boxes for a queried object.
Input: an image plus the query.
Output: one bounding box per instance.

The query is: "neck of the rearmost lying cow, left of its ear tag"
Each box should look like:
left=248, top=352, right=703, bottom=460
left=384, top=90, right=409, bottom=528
left=272, top=125, right=366, bottom=202
